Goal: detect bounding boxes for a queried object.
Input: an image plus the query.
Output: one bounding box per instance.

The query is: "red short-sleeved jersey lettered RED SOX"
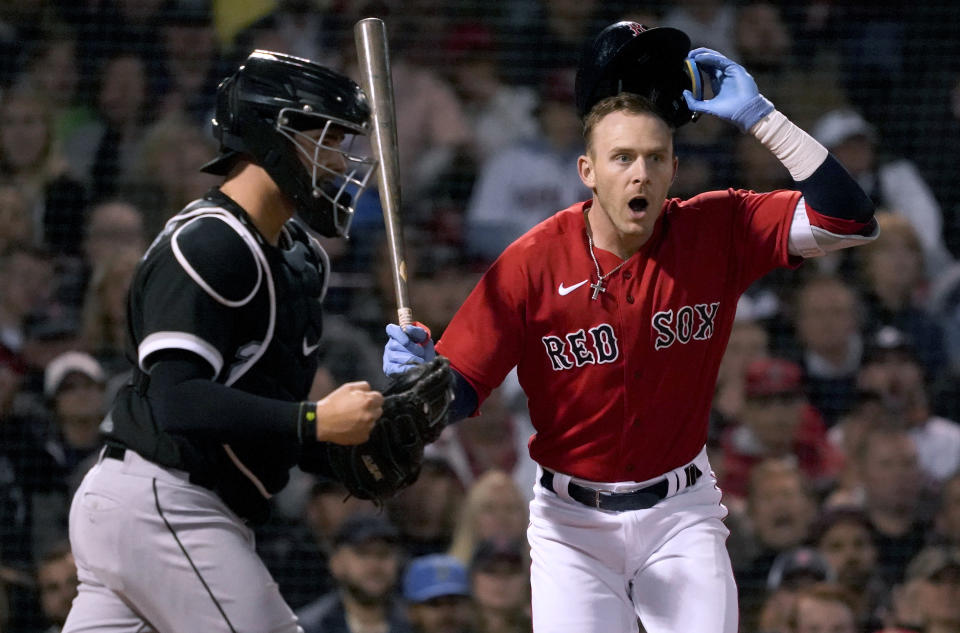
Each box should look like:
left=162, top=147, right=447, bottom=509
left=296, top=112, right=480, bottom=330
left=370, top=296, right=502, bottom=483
left=437, top=189, right=801, bottom=482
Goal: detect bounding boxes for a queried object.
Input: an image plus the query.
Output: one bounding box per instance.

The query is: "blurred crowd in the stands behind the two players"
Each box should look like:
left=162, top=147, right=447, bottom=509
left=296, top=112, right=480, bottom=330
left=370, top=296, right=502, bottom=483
left=0, top=0, right=960, bottom=633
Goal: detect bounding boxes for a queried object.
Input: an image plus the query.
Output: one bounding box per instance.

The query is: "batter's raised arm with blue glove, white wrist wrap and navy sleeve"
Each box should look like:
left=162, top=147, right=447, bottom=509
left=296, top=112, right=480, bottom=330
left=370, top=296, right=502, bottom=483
left=683, top=48, right=879, bottom=257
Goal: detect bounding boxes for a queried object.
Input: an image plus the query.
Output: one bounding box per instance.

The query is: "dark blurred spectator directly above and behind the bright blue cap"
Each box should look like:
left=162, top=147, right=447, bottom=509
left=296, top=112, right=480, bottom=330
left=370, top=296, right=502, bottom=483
left=387, top=457, right=464, bottom=556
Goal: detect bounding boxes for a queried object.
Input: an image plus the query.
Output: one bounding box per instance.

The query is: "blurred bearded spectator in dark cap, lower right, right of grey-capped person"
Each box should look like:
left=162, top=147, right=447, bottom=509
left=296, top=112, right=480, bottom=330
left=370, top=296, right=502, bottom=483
left=811, top=507, right=889, bottom=631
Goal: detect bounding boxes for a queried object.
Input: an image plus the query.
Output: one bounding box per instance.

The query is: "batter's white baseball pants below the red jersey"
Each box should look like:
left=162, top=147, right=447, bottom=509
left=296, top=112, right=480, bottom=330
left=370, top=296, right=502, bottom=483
left=527, top=450, right=739, bottom=633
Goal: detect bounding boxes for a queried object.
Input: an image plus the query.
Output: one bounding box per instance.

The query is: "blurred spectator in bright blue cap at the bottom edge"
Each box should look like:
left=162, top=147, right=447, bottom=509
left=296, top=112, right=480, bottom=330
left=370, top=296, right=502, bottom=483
left=403, top=554, right=473, bottom=633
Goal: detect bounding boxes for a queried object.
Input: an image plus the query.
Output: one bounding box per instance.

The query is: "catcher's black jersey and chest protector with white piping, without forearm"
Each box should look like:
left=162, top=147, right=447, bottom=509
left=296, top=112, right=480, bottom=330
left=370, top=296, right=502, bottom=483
left=102, top=190, right=329, bottom=520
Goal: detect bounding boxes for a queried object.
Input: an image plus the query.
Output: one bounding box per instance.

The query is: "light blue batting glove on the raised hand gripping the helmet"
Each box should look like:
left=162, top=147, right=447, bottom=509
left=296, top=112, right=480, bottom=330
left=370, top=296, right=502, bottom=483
left=683, top=48, right=773, bottom=132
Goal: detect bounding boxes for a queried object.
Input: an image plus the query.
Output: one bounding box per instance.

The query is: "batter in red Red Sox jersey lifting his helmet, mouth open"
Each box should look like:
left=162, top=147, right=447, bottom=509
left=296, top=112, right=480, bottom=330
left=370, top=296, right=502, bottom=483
left=384, top=22, right=876, bottom=633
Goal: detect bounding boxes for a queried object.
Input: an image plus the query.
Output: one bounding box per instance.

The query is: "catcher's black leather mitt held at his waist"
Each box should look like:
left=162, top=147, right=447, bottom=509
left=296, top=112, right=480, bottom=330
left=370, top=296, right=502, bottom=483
left=327, top=356, right=453, bottom=504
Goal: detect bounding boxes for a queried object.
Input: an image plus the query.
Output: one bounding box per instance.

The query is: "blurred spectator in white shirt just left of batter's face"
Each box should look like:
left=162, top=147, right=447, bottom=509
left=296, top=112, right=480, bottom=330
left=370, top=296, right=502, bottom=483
left=466, top=68, right=590, bottom=261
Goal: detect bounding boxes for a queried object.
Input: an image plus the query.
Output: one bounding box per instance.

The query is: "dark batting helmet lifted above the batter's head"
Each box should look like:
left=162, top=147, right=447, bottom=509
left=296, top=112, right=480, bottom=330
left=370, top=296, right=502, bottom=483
left=577, top=21, right=702, bottom=127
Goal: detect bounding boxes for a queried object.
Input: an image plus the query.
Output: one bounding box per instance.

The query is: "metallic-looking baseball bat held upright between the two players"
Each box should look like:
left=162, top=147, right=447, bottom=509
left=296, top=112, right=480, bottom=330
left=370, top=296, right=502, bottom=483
left=353, top=18, right=413, bottom=328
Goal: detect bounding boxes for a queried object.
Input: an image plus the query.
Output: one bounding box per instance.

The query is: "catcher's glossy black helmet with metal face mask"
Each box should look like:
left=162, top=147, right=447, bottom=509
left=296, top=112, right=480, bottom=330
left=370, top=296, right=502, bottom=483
left=201, top=50, right=376, bottom=237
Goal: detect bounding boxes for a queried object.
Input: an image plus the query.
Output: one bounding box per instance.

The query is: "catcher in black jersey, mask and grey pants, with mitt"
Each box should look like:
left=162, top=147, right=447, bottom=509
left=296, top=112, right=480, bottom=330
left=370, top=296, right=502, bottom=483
left=63, top=51, right=451, bottom=633
